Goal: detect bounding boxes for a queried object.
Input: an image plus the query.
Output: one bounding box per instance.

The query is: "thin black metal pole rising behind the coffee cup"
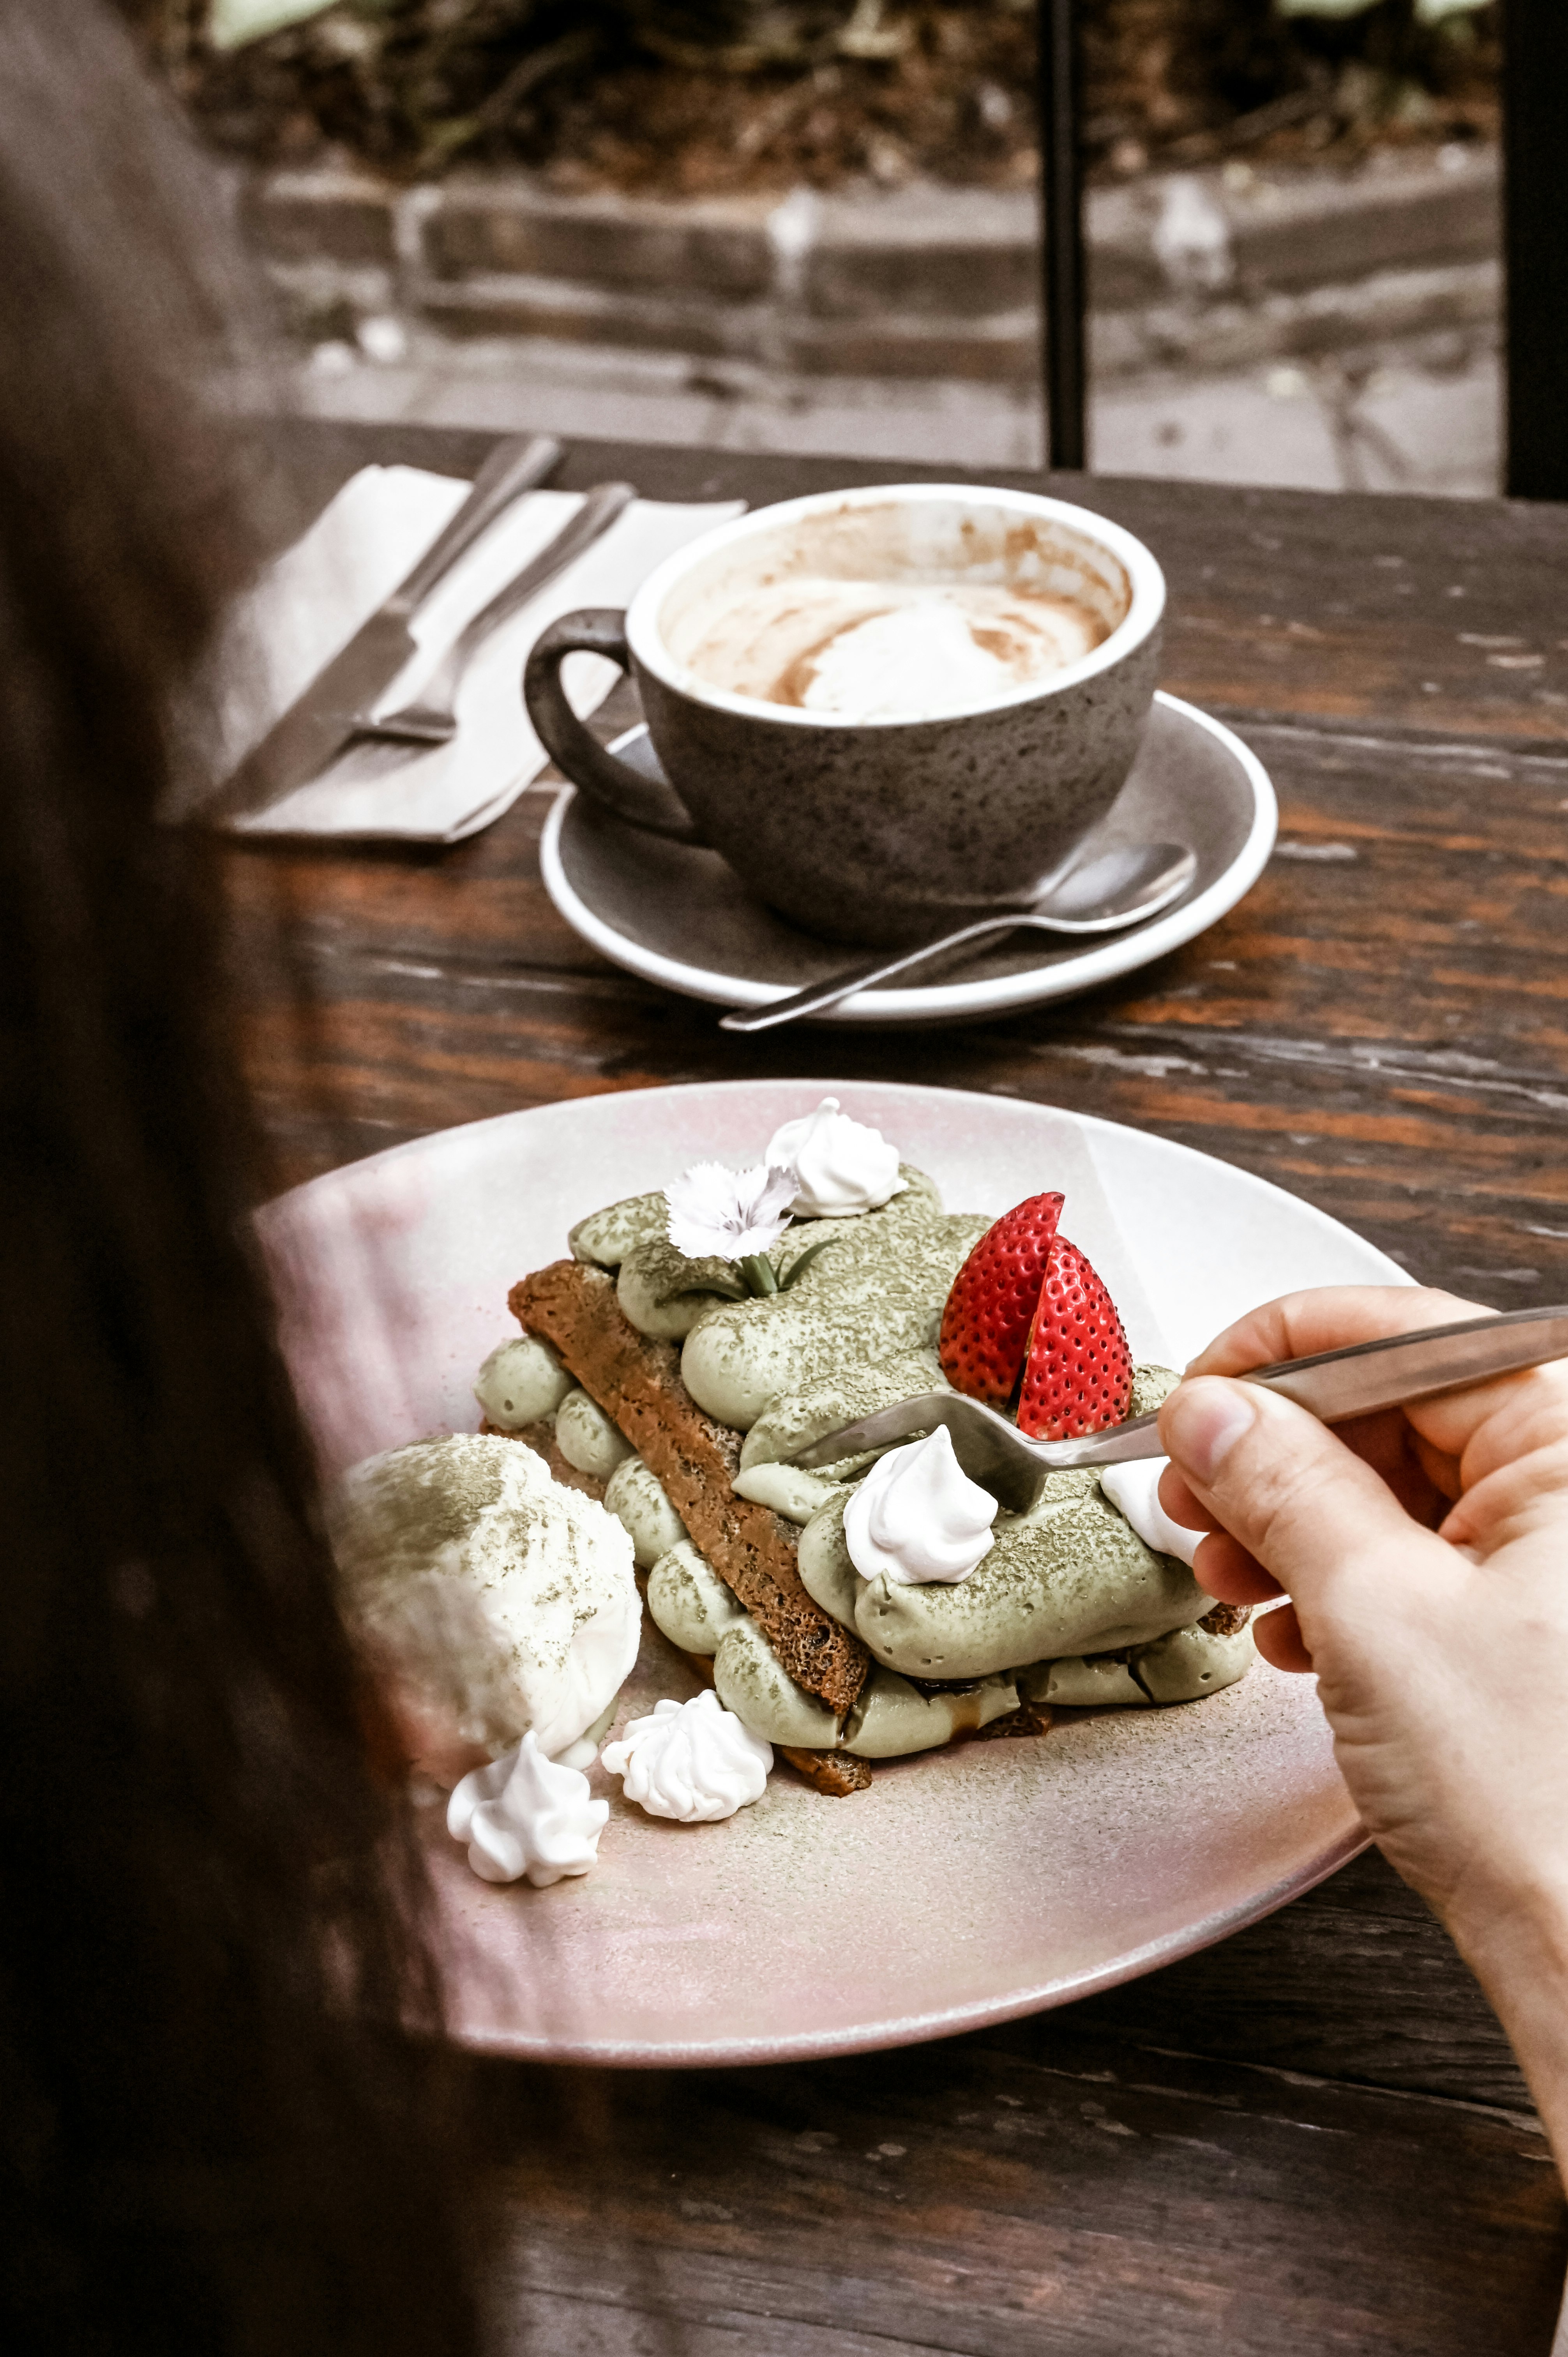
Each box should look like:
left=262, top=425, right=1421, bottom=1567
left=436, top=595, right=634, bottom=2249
left=1040, top=0, right=1084, bottom=469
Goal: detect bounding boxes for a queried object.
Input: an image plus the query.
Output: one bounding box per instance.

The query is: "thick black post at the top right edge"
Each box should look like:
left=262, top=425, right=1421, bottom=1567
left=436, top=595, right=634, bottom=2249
left=1502, top=0, right=1568, bottom=500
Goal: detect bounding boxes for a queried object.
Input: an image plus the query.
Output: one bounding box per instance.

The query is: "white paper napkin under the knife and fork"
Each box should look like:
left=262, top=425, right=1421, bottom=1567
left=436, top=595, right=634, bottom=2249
left=217, top=467, right=745, bottom=844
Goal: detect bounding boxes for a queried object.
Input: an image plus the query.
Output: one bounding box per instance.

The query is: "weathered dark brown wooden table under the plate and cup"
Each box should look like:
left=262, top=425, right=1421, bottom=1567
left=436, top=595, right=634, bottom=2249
left=226, top=427, right=1568, bottom=2357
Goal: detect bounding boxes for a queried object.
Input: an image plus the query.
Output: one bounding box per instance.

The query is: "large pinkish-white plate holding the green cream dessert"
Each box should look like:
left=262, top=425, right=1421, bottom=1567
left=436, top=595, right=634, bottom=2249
left=262, top=1080, right=1405, bottom=2065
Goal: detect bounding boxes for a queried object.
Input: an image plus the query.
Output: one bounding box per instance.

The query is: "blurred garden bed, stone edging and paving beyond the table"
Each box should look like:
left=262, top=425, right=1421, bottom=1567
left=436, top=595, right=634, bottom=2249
left=120, top=0, right=1502, bottom=495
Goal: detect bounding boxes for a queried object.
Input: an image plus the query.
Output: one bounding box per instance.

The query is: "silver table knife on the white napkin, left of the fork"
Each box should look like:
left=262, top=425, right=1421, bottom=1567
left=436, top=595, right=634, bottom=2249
left=200, top=434, right=561, bottom=825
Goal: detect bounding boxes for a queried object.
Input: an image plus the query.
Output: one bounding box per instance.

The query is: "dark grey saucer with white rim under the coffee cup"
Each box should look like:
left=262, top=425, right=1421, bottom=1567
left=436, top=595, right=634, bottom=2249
left=540, top=695, right=1278, bottom=1023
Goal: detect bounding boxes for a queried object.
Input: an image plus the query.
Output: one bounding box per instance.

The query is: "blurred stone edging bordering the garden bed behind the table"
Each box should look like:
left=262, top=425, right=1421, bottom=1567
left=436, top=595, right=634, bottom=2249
left=238, top=146, right=1500, bottom=384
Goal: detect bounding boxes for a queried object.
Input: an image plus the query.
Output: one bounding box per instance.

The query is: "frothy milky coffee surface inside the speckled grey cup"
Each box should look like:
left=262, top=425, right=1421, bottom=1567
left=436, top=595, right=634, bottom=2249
left=689, top=575, right=1108, bottom=719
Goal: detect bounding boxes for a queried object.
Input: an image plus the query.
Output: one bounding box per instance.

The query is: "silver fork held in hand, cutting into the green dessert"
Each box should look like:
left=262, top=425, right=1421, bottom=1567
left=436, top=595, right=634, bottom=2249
left=783, top=1304, right=1568, bottom=1513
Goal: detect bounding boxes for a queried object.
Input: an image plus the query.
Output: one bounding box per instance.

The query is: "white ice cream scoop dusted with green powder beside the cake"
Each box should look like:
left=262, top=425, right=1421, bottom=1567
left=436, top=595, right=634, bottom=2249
left=332, top=1433, right=641, bottom=1772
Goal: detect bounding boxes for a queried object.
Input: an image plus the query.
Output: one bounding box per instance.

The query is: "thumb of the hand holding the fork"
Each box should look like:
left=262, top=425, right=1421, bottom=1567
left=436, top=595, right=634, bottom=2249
left=1160, top=1374, right=1450, bottom=1605
